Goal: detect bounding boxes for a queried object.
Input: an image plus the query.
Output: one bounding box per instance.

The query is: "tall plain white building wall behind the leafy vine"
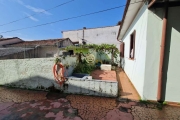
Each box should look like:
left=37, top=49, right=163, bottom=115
left=62, top=26, right=119, bottom=48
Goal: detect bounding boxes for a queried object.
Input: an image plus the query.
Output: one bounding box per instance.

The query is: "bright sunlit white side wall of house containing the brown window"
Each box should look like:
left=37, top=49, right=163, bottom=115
left=122, top=5, right=148, bottom=97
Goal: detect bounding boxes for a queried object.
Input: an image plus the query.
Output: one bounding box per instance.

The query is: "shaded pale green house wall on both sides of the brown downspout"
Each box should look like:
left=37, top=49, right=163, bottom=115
left=143, top=7, right=180, bottom=102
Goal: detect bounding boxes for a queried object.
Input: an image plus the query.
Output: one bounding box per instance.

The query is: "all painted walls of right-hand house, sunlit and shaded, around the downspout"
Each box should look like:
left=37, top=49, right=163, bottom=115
left=119, top=5, right=180, bottom=102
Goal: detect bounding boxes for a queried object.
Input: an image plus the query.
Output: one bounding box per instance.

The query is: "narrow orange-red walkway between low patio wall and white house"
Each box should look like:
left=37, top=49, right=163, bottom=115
left=117, top=68, right=140, bottom=100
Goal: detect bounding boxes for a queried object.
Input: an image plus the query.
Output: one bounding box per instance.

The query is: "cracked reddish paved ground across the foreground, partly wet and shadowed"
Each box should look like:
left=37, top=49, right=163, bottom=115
left=0, top=87, right=180, bottom=120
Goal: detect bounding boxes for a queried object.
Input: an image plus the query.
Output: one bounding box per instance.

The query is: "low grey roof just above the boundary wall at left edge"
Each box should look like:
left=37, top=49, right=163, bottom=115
left=0, top=47, right=37, bottom=60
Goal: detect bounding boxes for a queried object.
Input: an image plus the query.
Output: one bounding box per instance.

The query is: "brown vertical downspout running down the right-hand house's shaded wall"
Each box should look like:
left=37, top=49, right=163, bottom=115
left=157, top=0, right=168, bottom=102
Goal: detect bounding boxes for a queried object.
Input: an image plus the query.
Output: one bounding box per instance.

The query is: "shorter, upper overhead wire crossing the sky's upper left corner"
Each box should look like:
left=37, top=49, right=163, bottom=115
left=0, top=0, right=74, bottom=26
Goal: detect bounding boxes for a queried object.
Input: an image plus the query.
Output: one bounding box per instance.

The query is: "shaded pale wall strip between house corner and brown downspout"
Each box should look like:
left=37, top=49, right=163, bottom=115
left=143, top=8, right=163, bottom=100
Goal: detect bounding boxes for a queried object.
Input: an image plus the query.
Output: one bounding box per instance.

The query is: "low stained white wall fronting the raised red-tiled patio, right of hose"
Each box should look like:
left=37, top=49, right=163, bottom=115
left=64, top=76, right=118, bottom=97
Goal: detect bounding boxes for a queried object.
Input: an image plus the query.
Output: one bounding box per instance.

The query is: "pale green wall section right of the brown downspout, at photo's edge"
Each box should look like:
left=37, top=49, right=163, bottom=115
left=163, top=7, right=180, bottom=102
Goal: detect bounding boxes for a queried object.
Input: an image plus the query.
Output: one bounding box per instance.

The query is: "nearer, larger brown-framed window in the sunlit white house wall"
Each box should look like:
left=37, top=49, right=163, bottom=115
left=129, top=30, right=136, bottom=59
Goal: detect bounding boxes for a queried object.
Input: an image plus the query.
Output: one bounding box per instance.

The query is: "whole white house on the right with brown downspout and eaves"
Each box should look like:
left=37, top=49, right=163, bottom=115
left=117, top=0, right=180, bottom=102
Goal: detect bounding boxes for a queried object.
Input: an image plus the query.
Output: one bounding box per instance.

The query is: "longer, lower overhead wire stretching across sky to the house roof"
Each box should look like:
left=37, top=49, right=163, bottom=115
left=0, top=1, right=143, bottom=34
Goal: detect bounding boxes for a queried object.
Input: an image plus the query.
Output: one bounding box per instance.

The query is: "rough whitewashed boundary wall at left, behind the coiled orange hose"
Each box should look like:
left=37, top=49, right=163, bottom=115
left=0, top=57, right=76, bottom=89
